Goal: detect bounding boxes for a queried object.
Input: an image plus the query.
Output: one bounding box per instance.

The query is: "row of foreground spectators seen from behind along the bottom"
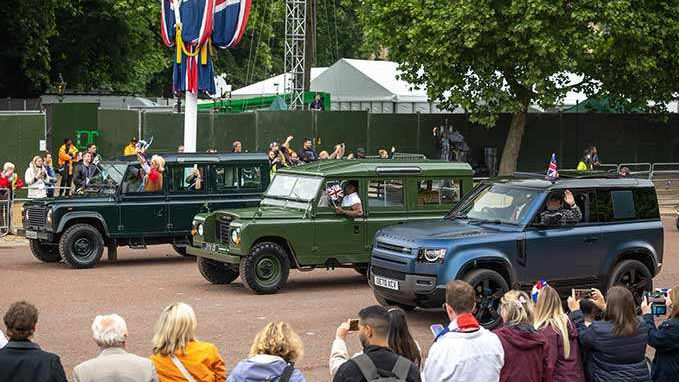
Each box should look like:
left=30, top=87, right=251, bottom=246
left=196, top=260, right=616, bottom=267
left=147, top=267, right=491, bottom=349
left=0, top=281, right=679, bottom=382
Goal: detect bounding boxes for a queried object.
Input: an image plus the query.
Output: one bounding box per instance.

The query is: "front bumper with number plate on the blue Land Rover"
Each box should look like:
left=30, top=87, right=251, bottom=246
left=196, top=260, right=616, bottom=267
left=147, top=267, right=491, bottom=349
left=368, top=266, right=446, bottom=308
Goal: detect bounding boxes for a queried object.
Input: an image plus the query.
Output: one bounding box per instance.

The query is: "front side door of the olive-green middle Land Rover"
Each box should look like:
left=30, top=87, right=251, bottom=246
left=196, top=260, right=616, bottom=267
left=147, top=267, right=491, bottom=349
left=312, top=179, right=369, bottom=264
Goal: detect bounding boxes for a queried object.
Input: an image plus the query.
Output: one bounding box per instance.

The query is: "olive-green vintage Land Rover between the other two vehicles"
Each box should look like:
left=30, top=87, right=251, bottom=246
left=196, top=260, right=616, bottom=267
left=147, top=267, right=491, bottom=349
left=187, top=159, right=472, bottom=294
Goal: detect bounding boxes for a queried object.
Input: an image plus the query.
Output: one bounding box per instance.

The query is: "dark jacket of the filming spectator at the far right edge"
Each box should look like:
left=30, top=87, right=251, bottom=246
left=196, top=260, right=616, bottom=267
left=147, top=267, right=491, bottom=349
left=644, top=314, right=679, bottom=382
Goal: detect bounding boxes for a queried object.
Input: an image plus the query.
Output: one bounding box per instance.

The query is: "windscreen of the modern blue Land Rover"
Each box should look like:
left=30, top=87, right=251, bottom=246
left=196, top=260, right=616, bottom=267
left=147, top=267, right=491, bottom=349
left=453, top=184, right=540, bottom=224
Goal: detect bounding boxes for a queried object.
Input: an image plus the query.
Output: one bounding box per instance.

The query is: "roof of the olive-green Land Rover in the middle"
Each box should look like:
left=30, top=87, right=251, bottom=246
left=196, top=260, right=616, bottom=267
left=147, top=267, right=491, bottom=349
left=278, top=159, right=473, bottom=177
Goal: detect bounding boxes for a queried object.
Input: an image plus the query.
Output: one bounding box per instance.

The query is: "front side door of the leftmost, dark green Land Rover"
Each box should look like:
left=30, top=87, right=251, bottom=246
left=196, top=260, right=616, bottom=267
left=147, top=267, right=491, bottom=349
left=118, top=165, right=168, bottom=237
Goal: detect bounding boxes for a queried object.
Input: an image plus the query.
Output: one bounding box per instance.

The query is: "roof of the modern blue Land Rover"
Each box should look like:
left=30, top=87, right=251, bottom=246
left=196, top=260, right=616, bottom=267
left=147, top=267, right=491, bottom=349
left=490, top=175, right=654, bottom=191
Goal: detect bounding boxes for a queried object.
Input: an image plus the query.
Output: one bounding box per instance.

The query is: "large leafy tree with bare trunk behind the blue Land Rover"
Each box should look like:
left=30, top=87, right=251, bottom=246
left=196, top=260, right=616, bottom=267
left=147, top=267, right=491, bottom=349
left=362, top=0, right=679, bottom=174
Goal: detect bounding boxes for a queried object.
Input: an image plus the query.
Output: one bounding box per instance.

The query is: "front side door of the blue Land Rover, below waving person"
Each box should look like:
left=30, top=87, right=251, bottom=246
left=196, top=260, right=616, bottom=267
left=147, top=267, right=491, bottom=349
left=515, top=189, right=607, bottom=293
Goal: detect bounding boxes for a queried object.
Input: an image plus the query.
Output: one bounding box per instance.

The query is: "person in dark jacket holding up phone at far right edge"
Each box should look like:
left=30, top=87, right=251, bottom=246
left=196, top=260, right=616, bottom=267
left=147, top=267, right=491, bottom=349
left=641, top=285, right=679, bottom=382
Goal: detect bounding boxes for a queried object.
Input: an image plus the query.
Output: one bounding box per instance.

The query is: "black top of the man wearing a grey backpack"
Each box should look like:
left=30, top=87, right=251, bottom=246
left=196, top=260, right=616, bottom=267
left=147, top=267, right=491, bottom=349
left=333, top=346, right=421, bottom=382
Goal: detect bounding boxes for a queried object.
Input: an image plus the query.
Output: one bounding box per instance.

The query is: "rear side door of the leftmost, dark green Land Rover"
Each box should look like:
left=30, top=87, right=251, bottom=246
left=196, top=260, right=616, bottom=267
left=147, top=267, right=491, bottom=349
left=165, top=162, right=208, bottom=235
